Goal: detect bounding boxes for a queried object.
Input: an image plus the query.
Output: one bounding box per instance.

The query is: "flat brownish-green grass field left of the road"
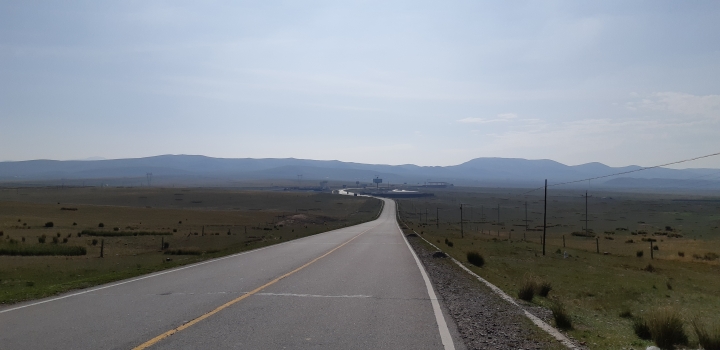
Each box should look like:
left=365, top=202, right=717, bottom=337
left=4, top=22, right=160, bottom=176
left=0, top=188, right=380, bottom=303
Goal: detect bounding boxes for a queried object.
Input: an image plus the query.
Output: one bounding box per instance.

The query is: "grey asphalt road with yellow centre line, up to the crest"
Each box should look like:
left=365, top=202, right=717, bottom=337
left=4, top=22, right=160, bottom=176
left=0, top=200, right=459, bottom=349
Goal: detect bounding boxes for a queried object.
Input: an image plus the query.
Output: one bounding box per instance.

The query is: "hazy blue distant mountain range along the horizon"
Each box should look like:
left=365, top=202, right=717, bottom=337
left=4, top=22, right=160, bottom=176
left=0, top=155, right=720, bottom=189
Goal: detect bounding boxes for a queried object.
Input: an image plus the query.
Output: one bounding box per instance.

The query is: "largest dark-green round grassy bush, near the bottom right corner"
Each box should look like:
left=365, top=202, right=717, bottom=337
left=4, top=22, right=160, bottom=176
left=647, top=308, right=688, bottom=349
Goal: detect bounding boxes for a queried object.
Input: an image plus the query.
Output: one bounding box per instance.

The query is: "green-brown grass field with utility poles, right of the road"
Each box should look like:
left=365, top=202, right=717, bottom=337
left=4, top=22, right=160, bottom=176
left=400, top=188, right=720, bottom=349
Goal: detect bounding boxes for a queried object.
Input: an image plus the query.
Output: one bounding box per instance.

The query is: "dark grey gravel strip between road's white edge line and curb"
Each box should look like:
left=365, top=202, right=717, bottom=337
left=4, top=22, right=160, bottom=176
left=407, top=235, right=565, bottom=349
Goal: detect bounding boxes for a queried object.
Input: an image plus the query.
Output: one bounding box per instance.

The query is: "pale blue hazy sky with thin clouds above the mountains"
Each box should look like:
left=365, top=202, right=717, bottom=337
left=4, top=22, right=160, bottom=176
left=0, top=0, right=720, bottom=168
